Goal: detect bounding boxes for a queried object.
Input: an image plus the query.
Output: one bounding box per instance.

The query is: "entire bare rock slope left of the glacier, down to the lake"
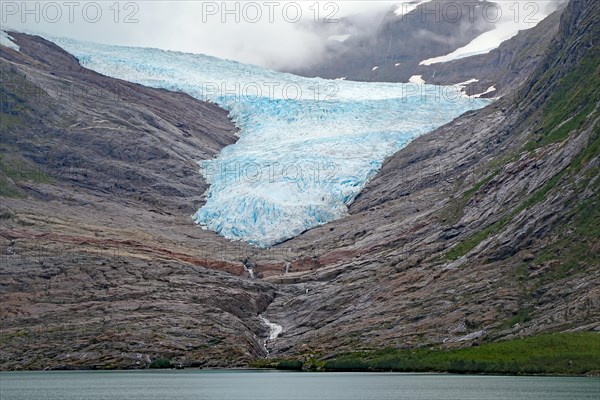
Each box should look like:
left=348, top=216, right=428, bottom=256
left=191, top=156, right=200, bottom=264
left=0, top=33, right=282, bottom=369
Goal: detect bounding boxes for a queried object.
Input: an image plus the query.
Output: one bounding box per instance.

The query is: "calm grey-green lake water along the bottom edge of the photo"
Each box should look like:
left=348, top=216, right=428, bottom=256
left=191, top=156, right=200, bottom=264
left=0, top=371, right=600, bottom=400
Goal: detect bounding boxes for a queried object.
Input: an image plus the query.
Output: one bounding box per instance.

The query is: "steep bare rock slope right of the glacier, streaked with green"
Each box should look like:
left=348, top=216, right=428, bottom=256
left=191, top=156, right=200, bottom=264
left=268, top=0, right=600, bottom=355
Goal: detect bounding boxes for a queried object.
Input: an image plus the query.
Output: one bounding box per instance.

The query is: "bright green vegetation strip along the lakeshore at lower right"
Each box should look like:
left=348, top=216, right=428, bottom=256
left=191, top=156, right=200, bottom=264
left=262, top=332, right=600, bottom=375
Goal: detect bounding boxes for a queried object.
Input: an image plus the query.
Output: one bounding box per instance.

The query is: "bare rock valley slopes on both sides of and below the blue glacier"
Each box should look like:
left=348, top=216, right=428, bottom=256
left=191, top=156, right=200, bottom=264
left=0, top=0, right=600, bottom=369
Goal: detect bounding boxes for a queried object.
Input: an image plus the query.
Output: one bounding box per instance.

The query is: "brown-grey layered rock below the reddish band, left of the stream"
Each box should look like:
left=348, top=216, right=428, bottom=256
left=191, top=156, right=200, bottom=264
left=0, top=255, right=274, bottom=369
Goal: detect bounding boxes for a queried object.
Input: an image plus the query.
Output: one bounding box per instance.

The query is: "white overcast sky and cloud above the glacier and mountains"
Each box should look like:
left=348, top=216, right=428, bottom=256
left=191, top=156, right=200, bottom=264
left=0, top=0, right=561, bottom=67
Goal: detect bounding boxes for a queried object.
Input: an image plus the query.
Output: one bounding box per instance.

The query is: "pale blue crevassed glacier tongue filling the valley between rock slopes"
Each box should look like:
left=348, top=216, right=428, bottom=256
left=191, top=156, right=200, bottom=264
left=53, top=39, right=488, bottom=247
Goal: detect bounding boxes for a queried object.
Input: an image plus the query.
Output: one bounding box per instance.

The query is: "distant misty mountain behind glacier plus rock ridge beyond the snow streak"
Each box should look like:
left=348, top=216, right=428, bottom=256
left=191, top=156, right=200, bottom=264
left=290, top=0, right=566, bottom=89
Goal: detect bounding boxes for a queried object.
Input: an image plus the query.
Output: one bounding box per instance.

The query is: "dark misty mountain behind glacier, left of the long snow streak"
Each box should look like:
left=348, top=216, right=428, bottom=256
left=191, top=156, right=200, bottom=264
left=286, top=0, right=495, bottom=82
